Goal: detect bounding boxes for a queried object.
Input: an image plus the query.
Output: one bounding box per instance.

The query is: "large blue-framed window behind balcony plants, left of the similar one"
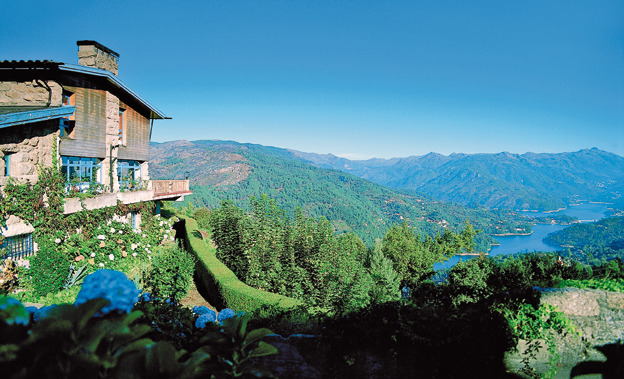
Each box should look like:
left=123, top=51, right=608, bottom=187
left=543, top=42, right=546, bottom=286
left=61, top=156, right=101, bottom=192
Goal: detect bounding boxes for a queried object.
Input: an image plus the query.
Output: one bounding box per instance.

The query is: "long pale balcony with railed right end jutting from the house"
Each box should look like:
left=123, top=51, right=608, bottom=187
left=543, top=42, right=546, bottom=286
left=63, top=180, right=193, bottom=214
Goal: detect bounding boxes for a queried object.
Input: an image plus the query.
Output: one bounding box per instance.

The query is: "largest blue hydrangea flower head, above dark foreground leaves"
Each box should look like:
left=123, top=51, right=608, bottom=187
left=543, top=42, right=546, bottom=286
left=74, top=270, right=141, bottom=316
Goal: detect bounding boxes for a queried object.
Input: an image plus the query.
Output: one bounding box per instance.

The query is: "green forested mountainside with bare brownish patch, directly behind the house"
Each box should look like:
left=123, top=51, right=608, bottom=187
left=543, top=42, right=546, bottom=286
left=150, top=141, right=530, bottom=249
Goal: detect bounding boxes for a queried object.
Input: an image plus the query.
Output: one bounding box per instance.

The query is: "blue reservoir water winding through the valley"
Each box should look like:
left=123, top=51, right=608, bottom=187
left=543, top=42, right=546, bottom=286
left=433, top=203, right=608, bottom=271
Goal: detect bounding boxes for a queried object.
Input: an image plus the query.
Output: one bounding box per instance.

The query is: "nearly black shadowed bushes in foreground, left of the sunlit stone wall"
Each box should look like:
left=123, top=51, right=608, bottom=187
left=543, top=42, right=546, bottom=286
left=318, top=300, right=514, bottom=378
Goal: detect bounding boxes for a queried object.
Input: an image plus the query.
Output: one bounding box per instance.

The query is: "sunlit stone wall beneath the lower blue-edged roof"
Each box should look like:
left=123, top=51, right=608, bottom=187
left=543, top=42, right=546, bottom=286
left=0, top=120, right=59, bottom=187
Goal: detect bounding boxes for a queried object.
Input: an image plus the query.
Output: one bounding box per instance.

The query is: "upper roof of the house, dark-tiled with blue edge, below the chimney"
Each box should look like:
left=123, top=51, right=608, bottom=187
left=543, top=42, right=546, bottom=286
left=0, top=60, right=171, bottom=120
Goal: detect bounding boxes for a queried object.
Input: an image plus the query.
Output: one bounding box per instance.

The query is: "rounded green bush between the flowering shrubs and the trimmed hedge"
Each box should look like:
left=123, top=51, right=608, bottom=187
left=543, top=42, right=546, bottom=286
left=144, top=244, right=195, bottom=301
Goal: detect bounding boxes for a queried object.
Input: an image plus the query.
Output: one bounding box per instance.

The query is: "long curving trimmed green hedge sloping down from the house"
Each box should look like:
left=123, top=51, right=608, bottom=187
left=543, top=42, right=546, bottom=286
left=178, top=215, right=303, bottom=312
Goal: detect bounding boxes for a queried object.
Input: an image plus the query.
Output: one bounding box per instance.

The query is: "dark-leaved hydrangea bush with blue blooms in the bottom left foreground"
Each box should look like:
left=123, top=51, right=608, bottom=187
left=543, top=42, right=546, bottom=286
left=0, top=270, right=277, bottom=378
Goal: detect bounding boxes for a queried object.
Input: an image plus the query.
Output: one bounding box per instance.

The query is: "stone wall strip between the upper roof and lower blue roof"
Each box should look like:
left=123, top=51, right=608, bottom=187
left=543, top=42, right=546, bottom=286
left=0, top=80, right=63, bottom=107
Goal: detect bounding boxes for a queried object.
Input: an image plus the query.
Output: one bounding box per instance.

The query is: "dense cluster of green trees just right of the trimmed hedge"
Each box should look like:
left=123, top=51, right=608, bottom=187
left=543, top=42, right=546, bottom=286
left=209, top=196, right=372, bottom=311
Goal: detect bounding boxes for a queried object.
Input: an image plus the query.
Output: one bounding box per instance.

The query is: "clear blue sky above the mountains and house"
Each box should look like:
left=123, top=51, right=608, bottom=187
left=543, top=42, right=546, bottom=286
left=0, top=0, right=624, bottom=159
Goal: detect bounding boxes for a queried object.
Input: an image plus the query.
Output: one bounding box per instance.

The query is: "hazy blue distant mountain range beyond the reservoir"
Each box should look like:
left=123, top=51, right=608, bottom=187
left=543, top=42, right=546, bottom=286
left=292, top=148, right=624, bottom=210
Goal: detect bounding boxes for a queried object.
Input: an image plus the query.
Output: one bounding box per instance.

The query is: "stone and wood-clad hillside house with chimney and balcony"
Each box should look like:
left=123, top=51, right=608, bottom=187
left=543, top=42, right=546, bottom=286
left=0, top=41, right=192, bottom=258
